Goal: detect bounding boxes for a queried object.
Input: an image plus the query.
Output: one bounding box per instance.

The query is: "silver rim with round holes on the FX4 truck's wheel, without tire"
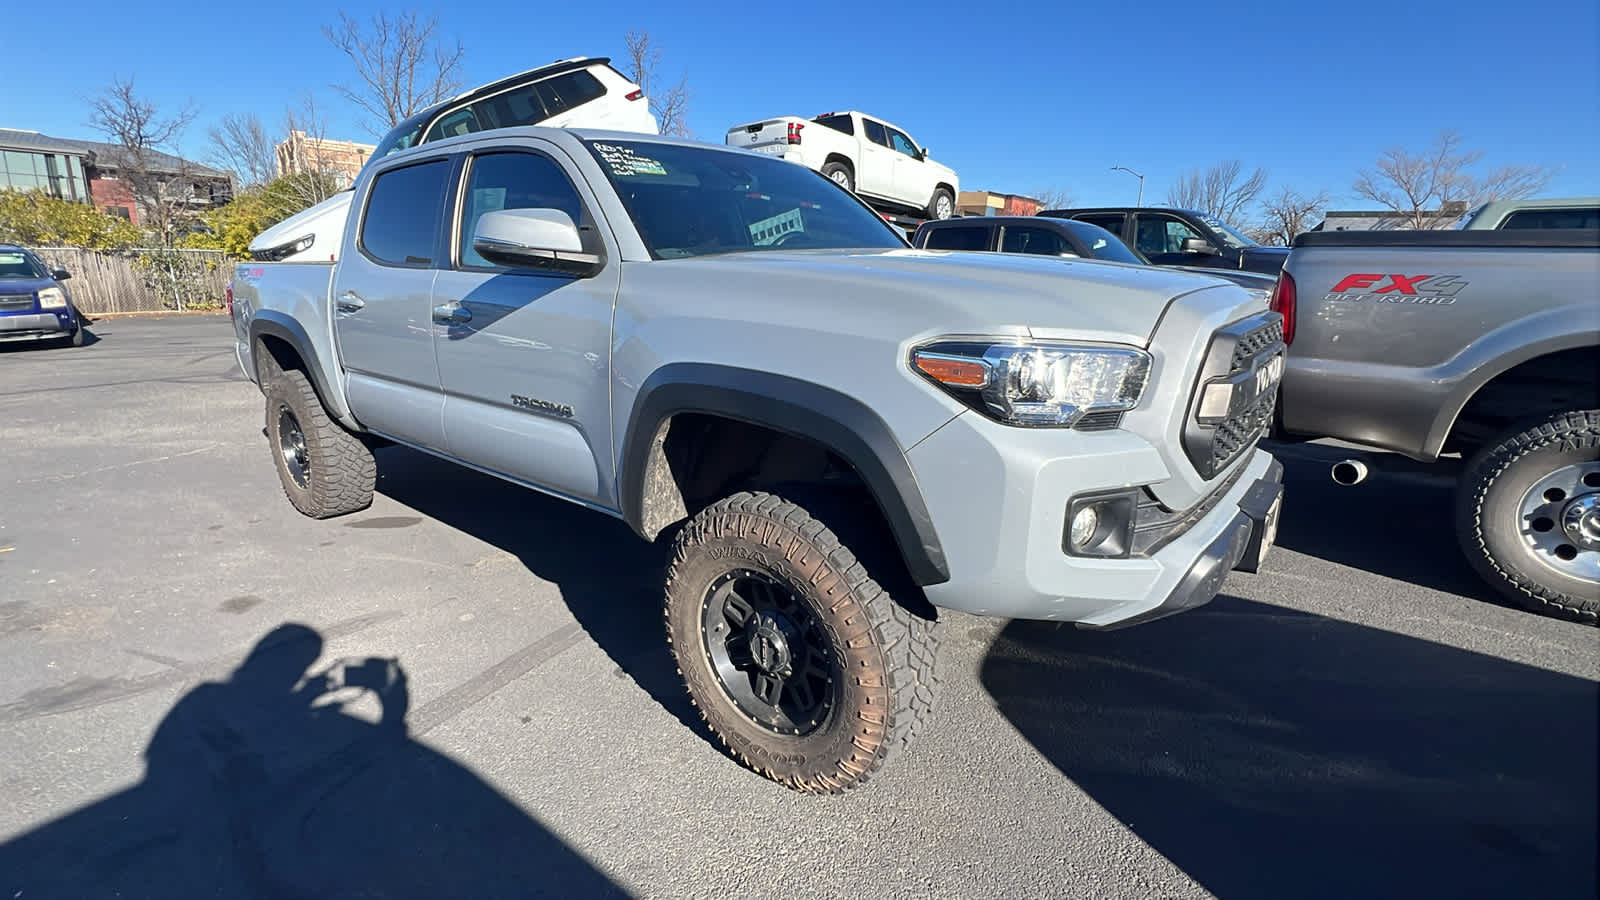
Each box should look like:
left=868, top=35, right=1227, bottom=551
left=1518, top=463, right=1600, bottom=583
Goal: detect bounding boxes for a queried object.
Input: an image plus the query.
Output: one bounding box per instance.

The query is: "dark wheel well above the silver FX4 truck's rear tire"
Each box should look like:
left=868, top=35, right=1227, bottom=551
left=1443, top=348, right=1600, bottom=455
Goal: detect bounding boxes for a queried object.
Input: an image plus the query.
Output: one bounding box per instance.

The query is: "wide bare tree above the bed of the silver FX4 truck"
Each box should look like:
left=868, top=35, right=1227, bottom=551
left=1354, top=131, right=1550, bottom=229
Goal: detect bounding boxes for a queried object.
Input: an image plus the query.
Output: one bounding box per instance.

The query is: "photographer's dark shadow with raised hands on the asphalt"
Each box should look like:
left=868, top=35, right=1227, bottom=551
left=0, top=625, right=626, bottom=898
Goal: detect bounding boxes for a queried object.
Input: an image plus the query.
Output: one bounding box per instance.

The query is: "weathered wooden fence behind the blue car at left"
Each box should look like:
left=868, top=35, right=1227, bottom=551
left=32, top=247, right=234, bottom=315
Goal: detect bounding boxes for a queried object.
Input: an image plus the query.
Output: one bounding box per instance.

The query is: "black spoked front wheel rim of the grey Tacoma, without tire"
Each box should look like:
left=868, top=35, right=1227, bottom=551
left=701, top=569, right=838, bottom=735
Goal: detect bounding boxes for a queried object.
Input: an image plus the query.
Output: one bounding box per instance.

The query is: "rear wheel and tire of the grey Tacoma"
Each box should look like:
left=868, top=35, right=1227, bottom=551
left=262, top=368, right=378, bottom=519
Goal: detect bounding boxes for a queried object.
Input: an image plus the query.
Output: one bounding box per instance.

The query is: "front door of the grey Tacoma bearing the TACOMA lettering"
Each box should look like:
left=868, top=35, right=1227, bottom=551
left=434, top=143, right=621, bottom=508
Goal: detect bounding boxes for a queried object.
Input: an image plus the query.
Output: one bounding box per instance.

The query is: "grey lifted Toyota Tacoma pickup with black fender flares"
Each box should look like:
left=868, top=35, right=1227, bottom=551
left=232, top=127, right=1283, bottom=793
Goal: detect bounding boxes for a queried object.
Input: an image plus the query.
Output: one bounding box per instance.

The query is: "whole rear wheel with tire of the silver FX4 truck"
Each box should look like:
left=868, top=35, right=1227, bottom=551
left=1458, top=410, right=1600, bottom=625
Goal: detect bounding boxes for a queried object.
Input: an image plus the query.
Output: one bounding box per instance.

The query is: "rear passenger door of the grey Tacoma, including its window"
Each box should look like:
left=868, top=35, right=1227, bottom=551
left=333, top=157, right=454, bottom=450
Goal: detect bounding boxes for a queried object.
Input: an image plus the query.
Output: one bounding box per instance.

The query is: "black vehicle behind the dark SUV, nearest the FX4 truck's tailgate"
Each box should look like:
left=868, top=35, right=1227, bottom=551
left=1038, top=207, right=1290, bottom=277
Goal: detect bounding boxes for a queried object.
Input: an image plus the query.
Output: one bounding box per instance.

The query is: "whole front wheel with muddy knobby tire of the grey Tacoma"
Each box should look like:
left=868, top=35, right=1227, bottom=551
left=666, top=493, right=936, bottom=794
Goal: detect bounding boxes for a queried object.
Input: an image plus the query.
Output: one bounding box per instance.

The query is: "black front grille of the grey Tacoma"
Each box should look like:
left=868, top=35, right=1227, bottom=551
left=1182, top=312, right=1288, bottom=479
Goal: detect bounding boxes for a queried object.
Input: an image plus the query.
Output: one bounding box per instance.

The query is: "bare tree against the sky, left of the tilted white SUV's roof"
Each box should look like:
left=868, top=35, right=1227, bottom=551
left=322, top=10, right=462, bottom=135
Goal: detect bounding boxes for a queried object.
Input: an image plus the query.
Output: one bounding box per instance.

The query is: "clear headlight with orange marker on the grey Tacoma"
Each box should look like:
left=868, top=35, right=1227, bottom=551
left=910, top=340, right=1150, bottom=429
